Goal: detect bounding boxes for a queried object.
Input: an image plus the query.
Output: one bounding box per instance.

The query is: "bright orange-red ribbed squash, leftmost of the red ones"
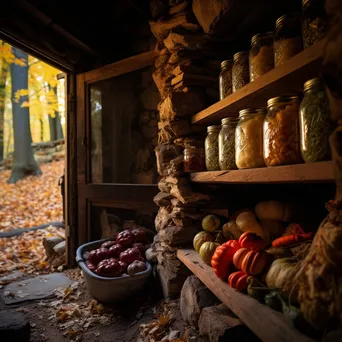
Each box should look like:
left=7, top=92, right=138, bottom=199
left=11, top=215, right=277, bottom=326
left=211, top=240, right=240, bottom=280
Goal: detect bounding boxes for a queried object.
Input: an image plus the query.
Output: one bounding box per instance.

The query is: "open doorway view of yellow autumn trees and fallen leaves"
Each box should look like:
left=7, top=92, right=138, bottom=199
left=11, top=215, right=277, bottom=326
left=0, top=40, right=66, bottom=276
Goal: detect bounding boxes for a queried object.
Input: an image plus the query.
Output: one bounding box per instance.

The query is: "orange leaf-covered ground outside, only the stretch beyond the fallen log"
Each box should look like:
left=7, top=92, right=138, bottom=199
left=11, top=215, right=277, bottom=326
left=0, top=160, right=64, bottom=232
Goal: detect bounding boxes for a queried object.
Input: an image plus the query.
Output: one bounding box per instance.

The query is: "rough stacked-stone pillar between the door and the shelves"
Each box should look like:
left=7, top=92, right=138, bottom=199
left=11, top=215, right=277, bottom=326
left=147, top=0, right=224, bottom=297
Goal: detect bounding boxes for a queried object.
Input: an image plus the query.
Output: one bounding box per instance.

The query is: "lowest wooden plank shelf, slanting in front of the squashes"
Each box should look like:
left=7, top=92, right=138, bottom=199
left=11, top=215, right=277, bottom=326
left=177, top=249, right=313, bottom=342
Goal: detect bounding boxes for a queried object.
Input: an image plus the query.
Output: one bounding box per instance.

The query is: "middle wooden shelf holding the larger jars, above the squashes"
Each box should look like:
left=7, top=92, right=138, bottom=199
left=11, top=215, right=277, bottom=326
left=190, top=161, right=335, bottom=184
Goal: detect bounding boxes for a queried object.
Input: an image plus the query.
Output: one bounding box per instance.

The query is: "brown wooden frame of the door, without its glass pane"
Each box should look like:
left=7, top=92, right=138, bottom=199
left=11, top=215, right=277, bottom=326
left=76, top=51, right=158, bottom=245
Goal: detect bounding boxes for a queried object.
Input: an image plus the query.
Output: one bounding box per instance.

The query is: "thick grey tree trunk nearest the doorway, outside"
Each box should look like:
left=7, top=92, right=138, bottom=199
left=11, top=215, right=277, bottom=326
left=8, top=47, right=42, bottom=183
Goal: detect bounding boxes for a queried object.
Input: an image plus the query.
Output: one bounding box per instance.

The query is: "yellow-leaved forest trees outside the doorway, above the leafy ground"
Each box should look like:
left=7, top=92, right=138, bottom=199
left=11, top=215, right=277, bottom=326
left=0, top=40, right=65, bottom=183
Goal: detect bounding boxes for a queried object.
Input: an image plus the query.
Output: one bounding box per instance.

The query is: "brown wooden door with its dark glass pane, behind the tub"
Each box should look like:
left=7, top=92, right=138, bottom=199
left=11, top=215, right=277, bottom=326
left=75, top=51, right=157, bottom=245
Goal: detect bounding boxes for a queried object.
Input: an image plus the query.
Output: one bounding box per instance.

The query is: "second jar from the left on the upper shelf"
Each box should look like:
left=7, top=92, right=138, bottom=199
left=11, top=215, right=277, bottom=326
left=232, top=51, right=249, bottom=93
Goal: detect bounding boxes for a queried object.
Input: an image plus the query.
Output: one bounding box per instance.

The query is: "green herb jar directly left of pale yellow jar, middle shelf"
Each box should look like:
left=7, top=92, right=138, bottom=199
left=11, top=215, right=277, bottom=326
left=219, top=118, right=239, bottom=170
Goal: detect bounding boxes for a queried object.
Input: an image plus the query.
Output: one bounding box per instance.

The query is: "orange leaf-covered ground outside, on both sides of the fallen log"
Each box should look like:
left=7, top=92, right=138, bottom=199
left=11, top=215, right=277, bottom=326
left=0, top=161, right=65, bottom=274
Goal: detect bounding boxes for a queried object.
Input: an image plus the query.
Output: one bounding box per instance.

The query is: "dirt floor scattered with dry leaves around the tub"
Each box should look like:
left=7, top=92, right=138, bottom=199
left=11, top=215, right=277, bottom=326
left=0, top=269, right=206, bottom=342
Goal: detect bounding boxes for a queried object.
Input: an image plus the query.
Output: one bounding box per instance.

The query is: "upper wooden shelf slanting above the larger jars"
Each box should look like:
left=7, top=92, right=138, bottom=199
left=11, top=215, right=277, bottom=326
left=191, top=40, right=325, bottom=125
